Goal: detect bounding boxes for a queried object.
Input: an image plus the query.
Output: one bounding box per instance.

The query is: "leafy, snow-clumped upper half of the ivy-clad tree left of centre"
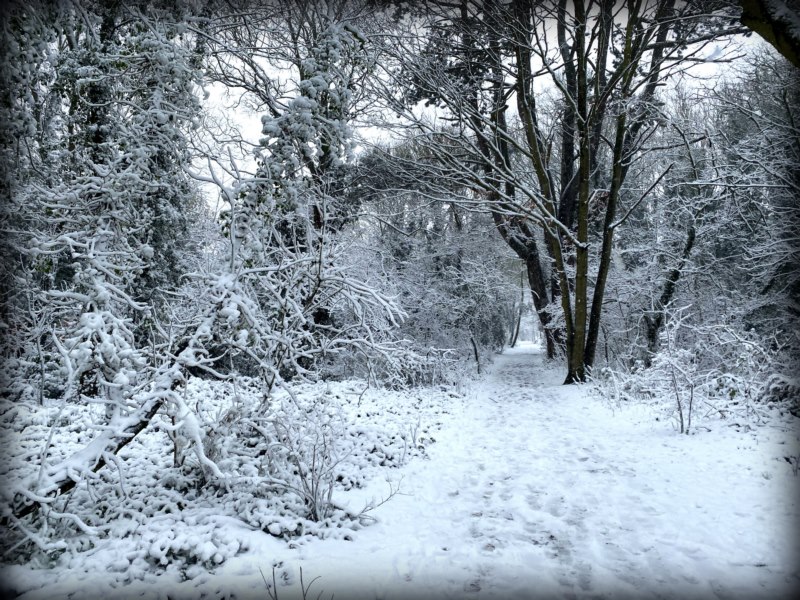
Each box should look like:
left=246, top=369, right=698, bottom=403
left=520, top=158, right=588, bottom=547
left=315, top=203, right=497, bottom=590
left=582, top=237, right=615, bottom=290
left=224, top=24, right=362, bottom=265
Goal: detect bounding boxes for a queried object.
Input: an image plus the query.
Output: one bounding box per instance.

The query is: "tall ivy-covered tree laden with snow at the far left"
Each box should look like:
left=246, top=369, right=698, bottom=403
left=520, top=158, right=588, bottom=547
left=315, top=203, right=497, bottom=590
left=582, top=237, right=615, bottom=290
left=3, top=1, right=199, bottom=414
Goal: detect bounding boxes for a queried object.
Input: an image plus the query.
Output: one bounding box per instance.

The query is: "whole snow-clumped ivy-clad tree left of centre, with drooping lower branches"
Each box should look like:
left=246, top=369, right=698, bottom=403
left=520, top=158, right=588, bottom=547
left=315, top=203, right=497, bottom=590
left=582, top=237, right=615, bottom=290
left=203, top=23, right=416, bottom=393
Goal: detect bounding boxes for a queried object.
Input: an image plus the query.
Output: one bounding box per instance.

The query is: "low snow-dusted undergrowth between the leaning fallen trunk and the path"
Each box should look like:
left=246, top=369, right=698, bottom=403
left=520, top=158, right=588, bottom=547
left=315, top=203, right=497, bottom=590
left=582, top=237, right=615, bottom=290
left=164, top=378, right=450, bottom=538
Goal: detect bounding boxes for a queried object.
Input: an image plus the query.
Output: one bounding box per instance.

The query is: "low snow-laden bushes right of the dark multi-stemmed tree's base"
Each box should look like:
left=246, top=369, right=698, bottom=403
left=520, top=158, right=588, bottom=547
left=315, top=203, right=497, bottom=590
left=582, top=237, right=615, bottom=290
left=593, top=311, right=800, bottom=433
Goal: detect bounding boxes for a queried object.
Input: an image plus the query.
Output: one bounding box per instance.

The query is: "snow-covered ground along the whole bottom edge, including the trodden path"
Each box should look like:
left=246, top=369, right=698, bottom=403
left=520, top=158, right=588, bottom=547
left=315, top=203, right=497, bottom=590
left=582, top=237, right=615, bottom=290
left=3, top=344, right=800, bottom=600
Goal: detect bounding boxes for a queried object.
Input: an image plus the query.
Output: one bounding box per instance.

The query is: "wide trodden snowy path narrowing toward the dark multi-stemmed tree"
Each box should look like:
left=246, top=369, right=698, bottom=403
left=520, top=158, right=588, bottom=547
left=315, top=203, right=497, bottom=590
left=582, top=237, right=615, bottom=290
left=248, top=347, right=800, bottom=598
